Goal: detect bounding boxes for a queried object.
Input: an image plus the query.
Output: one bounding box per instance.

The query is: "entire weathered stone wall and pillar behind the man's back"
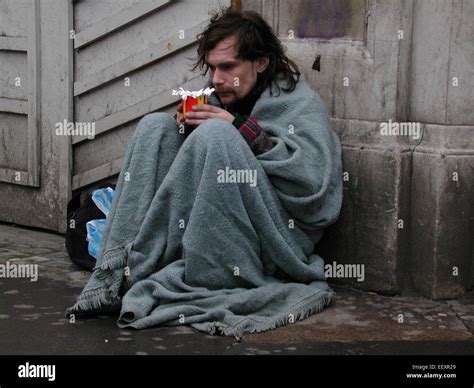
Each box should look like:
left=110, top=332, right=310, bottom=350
left=243, top=0, right=474, bottom=298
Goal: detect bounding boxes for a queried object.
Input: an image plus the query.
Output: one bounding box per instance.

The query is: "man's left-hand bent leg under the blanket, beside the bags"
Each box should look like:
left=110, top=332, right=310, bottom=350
left=66, top=113, right=184, bottom=316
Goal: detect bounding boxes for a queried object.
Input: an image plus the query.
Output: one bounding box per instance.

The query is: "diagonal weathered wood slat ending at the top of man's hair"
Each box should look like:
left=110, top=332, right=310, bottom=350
left=74, top=22, right=208, bottom=96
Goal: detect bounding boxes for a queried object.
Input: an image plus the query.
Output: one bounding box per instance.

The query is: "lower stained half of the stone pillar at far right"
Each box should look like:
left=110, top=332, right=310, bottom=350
left=410, top=125, right=474, bottom=298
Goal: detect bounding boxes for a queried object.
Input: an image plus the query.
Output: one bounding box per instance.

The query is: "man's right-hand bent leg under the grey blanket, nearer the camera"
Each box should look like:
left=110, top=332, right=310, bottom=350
left=127, top=116, right=312, bottom=288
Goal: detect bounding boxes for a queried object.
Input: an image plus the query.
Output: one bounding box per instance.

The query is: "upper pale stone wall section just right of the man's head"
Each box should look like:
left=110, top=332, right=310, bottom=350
left=282, top=0, right=413, bottom=121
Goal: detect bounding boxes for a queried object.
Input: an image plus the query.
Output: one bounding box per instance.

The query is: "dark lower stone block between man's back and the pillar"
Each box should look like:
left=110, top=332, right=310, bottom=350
left=321, top=148, right=400, bottom=294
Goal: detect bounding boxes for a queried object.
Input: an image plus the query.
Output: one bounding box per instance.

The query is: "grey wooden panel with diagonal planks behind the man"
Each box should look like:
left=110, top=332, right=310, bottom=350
left=72, top=0, right=230, bottom=190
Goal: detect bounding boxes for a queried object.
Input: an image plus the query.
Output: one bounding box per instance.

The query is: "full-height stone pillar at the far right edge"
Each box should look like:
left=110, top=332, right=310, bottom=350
left=410, top=0, right=474, bottom=298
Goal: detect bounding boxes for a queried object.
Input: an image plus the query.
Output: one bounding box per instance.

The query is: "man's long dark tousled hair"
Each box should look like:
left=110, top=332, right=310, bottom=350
left=193, top=9, right=301, bottom=95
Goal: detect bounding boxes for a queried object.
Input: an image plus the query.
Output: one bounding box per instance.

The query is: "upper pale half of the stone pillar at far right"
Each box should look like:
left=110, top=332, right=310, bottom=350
left=410, top=0, right=474, bottom=125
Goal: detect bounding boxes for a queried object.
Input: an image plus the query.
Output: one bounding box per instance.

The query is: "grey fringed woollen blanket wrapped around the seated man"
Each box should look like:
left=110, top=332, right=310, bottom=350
left=66, top=81, right=342, bottom=336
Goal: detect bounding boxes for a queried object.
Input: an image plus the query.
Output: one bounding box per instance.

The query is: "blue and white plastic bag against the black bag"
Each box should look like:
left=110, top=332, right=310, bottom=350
left=86, top=187, right=114, bottom=259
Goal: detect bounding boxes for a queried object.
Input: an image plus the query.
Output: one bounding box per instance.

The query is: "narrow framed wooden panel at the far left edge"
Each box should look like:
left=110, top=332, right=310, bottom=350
left=0, top=0, right=41, bottom=187
